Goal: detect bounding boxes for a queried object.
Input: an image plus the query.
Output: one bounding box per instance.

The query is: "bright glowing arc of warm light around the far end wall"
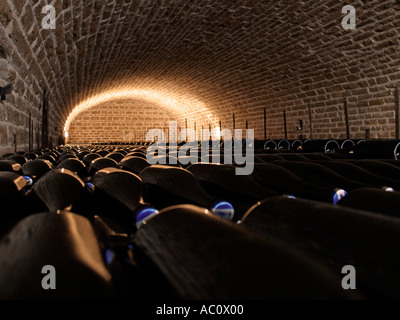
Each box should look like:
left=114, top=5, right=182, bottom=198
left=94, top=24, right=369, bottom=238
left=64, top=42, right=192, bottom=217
left=64, top=88, right=217, bottom=133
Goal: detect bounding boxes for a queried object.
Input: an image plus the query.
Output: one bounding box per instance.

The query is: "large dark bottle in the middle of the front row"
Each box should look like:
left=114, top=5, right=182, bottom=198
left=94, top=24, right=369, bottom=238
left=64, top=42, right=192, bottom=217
left=134, top=205, right=355, bottom=300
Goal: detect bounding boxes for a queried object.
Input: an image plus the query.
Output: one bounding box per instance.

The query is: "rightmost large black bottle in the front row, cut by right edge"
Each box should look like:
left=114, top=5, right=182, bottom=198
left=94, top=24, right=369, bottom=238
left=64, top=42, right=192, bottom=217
left=241, top=197, right=400, bottom=299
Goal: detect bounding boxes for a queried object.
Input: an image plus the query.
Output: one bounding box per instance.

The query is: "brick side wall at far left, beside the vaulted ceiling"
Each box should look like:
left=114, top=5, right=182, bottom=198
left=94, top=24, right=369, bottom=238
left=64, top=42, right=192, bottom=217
left=0, top=0, right=61, bottom=155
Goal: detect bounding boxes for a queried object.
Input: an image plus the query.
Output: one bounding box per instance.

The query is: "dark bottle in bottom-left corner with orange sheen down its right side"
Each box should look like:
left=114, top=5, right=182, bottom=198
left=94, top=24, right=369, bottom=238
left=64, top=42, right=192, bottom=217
left=0, top=212, right=114, bottom=300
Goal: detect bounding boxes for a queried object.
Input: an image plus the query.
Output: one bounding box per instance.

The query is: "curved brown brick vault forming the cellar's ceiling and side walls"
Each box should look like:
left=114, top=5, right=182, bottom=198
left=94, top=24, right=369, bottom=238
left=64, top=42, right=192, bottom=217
left=0, top=0, right=400, bottom=152
